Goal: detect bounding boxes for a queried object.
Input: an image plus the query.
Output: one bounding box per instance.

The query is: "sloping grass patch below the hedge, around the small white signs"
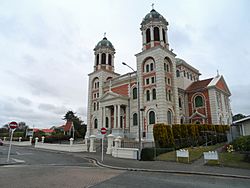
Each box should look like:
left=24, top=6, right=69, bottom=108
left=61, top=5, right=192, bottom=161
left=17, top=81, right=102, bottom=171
left=156, top=144, right=223, bottom=163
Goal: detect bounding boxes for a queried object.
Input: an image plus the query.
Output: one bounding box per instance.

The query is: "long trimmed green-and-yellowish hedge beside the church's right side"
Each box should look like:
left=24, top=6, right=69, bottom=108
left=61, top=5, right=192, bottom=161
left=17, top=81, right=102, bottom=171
left=153, top=124, right=229, bottom=149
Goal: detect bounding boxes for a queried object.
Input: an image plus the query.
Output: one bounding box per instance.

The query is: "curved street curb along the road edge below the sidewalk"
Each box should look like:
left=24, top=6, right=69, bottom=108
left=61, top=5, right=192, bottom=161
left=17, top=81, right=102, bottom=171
left=85, top=157, right=250, bottom=179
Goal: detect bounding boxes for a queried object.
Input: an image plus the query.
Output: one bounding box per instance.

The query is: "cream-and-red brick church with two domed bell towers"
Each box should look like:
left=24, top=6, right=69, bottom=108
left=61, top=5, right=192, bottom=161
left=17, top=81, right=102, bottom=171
left=87, top=9, right=232, bottom=140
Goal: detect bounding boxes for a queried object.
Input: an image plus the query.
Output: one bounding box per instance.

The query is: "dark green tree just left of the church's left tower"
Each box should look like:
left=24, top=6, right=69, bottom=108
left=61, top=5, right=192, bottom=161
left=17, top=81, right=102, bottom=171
left=63, top=111, right=87, bottom=138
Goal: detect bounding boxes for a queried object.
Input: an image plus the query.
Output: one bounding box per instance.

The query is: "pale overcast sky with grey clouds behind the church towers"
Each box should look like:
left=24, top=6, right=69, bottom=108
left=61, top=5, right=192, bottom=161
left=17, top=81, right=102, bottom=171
left=0, top=0, right=250, bottom=128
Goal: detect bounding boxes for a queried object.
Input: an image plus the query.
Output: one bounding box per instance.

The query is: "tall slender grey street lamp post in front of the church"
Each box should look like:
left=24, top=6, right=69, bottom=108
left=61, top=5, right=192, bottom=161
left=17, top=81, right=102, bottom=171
left=122, top=62, right=142, bottom=160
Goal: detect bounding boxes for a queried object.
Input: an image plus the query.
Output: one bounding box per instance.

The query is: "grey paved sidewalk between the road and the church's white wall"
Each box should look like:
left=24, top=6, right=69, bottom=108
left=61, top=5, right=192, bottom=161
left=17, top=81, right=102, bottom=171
left=73, top=153, right=250, bottom=179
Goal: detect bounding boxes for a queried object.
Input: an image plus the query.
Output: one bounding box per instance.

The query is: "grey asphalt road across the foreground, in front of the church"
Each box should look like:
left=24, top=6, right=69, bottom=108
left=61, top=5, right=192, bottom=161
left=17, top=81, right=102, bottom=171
left=0, top=146, right=250, bottom=188
